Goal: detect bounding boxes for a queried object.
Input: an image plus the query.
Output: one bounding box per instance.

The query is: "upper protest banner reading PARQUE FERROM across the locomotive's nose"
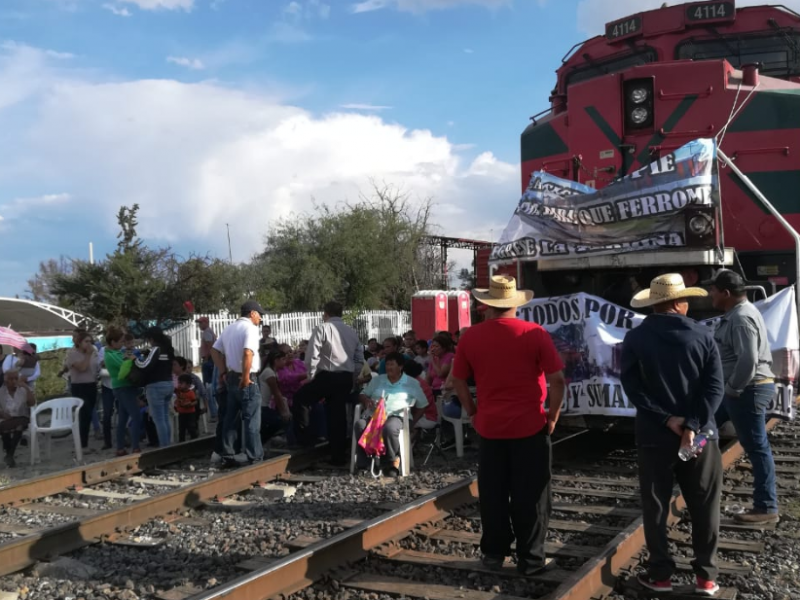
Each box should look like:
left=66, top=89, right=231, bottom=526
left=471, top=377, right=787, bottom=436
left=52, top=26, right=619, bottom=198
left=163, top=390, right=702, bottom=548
left=490, top=140, right=719, bottom=261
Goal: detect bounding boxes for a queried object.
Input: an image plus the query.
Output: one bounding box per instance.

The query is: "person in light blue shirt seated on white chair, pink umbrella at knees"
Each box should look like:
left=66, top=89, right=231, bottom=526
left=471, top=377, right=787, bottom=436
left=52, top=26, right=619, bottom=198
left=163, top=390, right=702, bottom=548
left=353, top=352, right=428, bottom=477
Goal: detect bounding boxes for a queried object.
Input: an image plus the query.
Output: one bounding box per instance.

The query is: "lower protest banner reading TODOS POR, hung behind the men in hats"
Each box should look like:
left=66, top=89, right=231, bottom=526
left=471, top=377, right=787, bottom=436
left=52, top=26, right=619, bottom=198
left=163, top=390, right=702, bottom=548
left=517, top=287, right=800, bottom=419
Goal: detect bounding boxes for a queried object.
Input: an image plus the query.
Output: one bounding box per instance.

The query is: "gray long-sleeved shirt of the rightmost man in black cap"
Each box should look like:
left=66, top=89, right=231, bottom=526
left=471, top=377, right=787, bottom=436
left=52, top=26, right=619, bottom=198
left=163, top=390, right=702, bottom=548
left=714, top=300, right=774, bottom=397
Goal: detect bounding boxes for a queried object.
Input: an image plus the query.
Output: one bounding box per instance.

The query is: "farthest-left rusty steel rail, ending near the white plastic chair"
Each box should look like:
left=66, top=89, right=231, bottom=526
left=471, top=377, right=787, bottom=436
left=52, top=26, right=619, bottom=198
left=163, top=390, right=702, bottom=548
left=0, top=436, right=214, bottom=506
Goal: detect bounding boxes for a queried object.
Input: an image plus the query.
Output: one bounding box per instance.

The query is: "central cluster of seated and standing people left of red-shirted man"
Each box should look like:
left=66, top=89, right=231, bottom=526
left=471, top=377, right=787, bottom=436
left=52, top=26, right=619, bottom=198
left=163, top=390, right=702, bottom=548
left=203, top=301, right=472, bottom=476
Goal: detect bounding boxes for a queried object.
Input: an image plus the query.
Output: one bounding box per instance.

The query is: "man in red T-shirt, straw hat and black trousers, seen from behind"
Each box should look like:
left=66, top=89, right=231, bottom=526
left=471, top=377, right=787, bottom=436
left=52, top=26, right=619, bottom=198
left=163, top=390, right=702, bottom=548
left=452, top=275, right=564, bottom=576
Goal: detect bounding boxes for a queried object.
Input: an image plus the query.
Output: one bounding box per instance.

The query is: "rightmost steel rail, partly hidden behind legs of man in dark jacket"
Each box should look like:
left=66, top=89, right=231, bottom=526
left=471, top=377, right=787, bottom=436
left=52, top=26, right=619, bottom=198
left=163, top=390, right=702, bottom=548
left=548, top=419, right=780, bottom=600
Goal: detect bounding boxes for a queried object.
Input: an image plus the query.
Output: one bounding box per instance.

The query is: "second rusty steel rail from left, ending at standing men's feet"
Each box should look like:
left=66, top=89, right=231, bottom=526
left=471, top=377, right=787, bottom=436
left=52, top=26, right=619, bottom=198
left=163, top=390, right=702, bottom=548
left=0, top=448, right=322, bottom=575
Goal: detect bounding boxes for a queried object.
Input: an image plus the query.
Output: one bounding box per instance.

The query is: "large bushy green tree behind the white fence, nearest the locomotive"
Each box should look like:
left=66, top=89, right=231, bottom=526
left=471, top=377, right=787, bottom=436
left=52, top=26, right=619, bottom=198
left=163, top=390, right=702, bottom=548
left=255, top=185, right=431, bottom=311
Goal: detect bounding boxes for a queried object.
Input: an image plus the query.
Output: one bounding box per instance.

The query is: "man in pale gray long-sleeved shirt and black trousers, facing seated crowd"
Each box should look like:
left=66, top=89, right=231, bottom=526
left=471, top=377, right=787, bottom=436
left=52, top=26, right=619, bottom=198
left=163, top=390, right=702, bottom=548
left=292, top=302, right=364, bottom=465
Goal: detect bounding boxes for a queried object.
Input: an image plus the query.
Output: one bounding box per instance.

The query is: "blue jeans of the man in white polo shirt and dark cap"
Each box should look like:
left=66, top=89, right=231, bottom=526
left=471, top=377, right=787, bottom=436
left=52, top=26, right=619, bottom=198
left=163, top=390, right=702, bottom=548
left=222, top=372, right=264, bottom=462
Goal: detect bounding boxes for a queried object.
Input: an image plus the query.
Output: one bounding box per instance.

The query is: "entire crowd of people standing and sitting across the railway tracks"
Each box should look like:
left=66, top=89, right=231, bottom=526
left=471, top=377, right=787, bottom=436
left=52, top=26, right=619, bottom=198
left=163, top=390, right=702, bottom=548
left=0, top=270, right=779, bottom=596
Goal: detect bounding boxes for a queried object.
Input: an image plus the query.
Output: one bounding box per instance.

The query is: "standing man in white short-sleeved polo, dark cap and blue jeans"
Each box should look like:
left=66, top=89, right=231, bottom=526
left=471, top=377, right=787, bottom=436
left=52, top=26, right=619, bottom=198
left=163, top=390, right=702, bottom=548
left=211, top=300, right=265, bottom=466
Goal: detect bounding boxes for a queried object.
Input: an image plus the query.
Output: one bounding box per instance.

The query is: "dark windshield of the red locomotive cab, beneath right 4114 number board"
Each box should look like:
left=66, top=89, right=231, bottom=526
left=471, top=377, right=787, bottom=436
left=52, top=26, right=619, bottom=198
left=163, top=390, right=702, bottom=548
left=675, top=32, right=800, bottom=78
